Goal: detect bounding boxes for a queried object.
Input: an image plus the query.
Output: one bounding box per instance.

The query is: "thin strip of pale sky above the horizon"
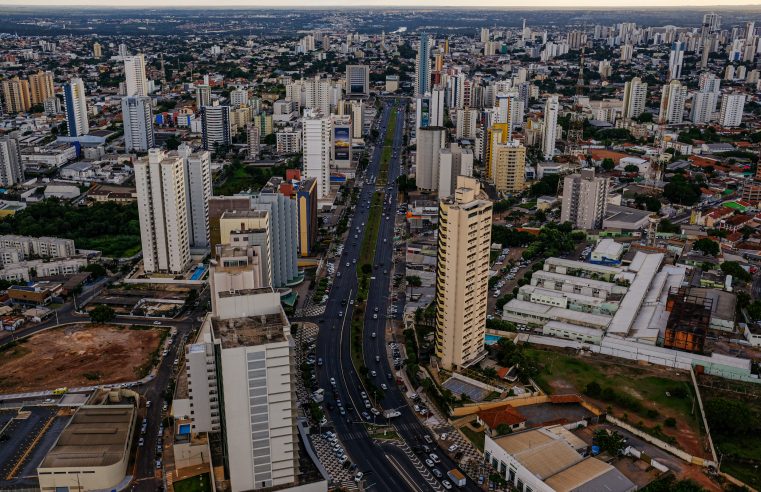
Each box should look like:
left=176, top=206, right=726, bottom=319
left=0, top=0, right=761, bottom=9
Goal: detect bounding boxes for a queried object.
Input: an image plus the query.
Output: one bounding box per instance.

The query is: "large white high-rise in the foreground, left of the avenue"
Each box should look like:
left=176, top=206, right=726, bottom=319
left=185, top=286, right=300, bottom=492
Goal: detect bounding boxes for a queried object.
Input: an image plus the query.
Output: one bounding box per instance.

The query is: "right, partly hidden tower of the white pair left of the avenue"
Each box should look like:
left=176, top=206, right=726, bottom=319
left=177, top=143, right=212, bottom=249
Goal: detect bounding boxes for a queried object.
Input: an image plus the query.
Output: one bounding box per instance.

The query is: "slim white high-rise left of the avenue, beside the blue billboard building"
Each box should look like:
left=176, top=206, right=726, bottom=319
left=301, top=110, right=332, bottom=199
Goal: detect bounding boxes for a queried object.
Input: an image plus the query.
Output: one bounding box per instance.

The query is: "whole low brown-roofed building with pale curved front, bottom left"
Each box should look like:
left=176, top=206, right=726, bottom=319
left=37, top=405, right=137, bottom=492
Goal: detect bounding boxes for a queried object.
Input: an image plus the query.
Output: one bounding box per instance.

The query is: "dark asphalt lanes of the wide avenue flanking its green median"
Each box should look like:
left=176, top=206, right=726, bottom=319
left=317, top=103, right=477, bottom=491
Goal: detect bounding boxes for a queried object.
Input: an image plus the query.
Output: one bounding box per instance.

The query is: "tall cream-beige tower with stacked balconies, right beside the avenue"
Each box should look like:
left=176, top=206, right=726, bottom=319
left=436, top=176, right=492, bottom=369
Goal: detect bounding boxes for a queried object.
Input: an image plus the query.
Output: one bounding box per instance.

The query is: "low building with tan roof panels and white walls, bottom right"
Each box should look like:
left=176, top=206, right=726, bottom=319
left=484, top=427, right=637, bottom=492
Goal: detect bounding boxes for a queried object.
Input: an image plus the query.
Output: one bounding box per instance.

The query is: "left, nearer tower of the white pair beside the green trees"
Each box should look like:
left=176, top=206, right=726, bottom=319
left=135, top=148, right=190, bottom=274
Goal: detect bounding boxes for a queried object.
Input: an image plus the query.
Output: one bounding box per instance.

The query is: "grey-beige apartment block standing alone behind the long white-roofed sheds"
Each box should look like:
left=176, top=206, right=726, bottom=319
left=560, top=169, right=609, bottom=229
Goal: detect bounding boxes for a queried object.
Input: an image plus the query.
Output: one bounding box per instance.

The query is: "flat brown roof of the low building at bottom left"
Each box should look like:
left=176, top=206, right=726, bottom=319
left=39, top=405, right=135, bottom=469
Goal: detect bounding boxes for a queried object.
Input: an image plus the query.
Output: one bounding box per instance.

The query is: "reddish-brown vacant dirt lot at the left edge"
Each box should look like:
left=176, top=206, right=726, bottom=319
left=0, top=323, right=162, bottom=393
